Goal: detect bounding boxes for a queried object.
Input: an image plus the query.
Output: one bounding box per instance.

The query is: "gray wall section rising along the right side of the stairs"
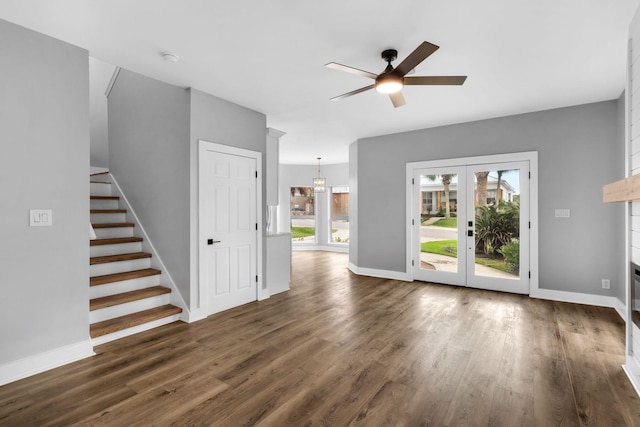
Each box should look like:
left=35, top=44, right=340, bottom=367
left=108, top=70, right=189, bottom=301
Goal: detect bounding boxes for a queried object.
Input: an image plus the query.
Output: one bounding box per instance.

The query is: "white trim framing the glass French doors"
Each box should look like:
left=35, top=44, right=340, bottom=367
left=405, top=151, right=539, bottom=295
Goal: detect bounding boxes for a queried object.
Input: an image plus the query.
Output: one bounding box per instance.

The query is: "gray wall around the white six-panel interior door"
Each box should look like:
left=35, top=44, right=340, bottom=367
left=188, top=89, right=267, bottom=301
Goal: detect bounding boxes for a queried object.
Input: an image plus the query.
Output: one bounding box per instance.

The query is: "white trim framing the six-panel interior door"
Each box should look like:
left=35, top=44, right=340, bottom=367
left=196, top=139, right=269, bottom=317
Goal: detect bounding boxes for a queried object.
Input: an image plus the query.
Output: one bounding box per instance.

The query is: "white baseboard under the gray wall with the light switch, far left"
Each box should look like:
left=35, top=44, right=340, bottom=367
left=0, top=340, right=95, bottom=386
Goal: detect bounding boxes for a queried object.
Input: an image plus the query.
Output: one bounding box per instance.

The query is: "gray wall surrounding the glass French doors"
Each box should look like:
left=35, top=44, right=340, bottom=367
left=349, top=100, right=624, bottom=296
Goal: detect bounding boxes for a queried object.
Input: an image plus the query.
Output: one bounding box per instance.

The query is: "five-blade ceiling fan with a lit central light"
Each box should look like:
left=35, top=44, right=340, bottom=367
left=326, top=42, right=467, bottom=108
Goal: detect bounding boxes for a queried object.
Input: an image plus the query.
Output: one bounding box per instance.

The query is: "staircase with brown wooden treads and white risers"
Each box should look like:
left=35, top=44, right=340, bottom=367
left=89, top=172, right=182, bottom=345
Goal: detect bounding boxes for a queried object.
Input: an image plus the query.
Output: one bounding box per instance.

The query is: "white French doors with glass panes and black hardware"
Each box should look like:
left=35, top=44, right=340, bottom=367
left=411, top=161, right=530, bottom=294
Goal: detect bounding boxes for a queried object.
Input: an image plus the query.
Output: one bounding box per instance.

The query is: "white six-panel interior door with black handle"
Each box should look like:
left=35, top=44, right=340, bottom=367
left=199, top=144, right=258, bottom=314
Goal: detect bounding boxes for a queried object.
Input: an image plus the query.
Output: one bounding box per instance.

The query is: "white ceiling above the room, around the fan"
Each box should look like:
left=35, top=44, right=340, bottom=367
left=0, top=0, right=640, bottom=164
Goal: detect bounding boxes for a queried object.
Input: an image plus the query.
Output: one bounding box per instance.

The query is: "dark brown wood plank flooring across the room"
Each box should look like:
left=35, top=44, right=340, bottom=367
left=0, top=252, right=640, bottom=426
